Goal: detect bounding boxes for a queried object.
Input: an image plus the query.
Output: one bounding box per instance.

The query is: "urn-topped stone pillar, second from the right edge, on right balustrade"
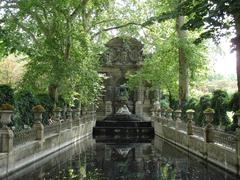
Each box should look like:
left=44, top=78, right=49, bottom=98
left=204, top=108, right=215, bottom=143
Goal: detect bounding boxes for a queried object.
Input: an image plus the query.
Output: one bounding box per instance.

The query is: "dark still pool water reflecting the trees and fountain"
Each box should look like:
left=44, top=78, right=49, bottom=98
left=3, top=137, right=240, bottom=180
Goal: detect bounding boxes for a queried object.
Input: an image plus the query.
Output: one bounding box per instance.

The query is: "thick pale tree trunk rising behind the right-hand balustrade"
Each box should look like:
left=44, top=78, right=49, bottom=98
left=176, top=16, right=189, bottom=109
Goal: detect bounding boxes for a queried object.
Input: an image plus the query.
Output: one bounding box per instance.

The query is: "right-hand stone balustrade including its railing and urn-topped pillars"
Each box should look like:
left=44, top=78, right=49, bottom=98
left=152, top=110, right=240, bottom=175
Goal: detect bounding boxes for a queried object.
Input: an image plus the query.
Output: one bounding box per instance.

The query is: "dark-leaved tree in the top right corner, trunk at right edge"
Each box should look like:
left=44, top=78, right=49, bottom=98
left=180, top=0, right=240, bottom=100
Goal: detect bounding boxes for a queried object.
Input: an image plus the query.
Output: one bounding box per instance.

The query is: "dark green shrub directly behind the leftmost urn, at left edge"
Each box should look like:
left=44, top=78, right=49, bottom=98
left=0, top=85, right=14, bottom=104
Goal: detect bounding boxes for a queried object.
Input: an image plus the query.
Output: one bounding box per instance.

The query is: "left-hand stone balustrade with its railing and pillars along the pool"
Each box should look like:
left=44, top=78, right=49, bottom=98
left=0, top=108, right=96, bottom=179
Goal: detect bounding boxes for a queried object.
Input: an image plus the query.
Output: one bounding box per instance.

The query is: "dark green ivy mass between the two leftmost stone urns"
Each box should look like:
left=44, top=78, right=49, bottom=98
left=14, top=91, right=36, bottom=127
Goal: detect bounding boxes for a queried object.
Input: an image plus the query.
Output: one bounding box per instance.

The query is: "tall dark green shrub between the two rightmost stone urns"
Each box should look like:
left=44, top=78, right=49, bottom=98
left=211, top=90, right=230, bottom=126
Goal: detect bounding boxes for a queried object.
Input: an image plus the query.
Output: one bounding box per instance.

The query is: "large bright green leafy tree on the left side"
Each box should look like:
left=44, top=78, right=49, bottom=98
left=0, top=0, right=107, bottom=105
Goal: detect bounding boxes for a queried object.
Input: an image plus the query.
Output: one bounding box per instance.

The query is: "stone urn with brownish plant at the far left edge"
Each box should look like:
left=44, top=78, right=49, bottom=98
left=0, top=103, right=14, bottom=127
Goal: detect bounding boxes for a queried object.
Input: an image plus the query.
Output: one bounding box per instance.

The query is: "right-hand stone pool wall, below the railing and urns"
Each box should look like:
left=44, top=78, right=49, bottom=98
left=153, top=116, right=240, bottom=175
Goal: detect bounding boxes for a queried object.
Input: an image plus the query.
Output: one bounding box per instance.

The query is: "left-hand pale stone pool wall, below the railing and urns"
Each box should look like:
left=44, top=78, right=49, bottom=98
left=0, top=114, right=96, bottom=178
